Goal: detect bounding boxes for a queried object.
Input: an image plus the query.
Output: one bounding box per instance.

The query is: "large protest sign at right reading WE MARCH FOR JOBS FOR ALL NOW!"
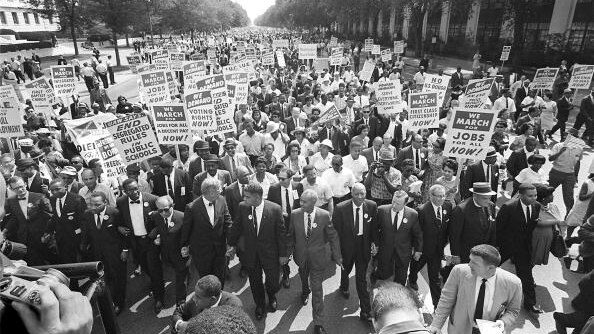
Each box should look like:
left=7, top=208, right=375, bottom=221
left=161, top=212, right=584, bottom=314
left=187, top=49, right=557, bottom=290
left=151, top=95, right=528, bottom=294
left=443, top=109, right=497, bottom=160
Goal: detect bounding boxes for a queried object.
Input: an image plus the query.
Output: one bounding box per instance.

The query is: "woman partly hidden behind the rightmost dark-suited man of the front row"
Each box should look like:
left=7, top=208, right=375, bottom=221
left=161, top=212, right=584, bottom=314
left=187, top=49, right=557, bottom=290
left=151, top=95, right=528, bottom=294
left=532, top=184, right=563, bottom=265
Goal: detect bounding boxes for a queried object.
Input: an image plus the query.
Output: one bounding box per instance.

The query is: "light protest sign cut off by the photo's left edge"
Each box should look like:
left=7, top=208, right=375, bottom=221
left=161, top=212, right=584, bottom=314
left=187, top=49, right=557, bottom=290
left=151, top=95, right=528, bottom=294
left=0, top=85, right=25, bottom=139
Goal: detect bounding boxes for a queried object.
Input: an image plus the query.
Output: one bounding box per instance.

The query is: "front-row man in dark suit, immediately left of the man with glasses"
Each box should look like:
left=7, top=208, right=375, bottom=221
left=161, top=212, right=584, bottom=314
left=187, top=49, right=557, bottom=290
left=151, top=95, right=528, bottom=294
left=372, top=190, right=423, bottom=285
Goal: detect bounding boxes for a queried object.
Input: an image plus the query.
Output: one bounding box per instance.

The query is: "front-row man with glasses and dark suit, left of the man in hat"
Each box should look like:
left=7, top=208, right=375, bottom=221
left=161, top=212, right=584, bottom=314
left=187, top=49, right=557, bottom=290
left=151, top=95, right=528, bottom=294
left=408, top=184, right=452, bottom=307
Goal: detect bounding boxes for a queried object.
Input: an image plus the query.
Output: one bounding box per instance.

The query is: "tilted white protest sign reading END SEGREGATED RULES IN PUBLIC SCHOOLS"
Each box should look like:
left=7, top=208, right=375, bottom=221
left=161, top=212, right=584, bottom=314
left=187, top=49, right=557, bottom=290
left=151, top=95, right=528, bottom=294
left=103, top=113, right=161, bottom=165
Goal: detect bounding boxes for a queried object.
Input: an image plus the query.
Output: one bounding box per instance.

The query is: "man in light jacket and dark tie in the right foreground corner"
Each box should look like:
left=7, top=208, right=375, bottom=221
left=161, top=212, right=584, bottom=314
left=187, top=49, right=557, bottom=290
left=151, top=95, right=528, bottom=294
left=428, top=245, right=522, bottom=334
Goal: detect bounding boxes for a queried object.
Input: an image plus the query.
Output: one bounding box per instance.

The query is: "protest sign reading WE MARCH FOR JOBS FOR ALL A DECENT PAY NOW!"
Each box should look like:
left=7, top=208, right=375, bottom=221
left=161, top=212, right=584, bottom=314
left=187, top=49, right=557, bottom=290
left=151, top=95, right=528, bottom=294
left=153, top=103, right=192, bottom=145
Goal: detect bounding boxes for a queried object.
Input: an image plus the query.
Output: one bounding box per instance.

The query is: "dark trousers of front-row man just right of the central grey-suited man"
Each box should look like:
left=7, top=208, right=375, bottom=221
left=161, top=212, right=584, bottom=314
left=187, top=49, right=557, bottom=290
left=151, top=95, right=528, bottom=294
left=340, top=236, right=371, bottom=313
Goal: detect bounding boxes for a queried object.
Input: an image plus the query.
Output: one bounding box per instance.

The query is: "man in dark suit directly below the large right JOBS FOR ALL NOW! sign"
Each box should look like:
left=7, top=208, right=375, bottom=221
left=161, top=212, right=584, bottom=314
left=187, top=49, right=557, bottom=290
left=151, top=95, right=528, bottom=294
left=460, top=146, right=499, bottom=203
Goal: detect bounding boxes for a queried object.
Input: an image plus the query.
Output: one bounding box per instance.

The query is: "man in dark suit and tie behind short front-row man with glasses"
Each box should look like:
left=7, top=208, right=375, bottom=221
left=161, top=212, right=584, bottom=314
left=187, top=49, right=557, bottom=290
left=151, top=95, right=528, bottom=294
left=152, top=160, right=192, bottom=211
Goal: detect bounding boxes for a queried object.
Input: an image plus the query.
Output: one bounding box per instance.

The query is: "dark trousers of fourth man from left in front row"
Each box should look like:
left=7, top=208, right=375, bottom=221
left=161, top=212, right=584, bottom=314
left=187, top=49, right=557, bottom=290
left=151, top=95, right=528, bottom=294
left=134, top=237, right=165, bottom=302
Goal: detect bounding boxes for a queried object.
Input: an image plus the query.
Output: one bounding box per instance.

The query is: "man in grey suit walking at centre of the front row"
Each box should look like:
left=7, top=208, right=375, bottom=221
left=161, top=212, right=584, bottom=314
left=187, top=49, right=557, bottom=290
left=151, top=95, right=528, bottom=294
left=287, top=189, right=344, bottom=334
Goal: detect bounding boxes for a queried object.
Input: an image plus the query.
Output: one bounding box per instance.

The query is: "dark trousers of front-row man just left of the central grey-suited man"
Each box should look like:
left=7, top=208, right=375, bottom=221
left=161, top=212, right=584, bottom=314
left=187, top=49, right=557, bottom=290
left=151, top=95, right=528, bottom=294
left=247, top=255, right=280, bottom=308
